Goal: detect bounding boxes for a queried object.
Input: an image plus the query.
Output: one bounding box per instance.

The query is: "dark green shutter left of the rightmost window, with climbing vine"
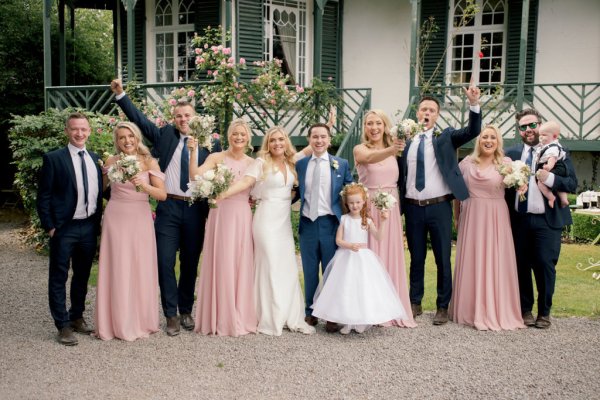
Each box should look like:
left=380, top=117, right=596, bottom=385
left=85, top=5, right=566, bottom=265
left=419, top=0, right=448, bottom=90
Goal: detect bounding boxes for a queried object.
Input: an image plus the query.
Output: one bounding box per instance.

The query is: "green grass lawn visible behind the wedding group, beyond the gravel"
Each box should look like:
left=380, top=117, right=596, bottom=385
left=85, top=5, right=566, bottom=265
left=90, top=244, right=600, bottom=318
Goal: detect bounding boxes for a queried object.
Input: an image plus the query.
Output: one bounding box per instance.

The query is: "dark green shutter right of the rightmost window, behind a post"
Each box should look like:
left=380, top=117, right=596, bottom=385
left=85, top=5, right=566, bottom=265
left=504, top=0, right=539, bottom=89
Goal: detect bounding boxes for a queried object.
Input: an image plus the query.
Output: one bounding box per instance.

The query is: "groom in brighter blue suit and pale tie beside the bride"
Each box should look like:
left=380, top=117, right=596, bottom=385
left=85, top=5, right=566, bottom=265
left=296, top=123, right=353, bottom=332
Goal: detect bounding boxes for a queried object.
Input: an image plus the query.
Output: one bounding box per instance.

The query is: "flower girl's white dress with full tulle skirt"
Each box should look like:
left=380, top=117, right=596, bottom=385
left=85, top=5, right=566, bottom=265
left=313, top=214, right=406, bottom=331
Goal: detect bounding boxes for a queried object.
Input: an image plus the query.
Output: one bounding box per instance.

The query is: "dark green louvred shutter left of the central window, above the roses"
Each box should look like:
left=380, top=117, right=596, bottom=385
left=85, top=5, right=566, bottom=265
left=235, top=0, right=264, bottom=80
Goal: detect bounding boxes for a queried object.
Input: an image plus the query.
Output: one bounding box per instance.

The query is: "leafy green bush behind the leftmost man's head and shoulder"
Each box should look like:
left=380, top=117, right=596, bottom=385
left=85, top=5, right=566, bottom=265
left=9, top=109, right=117, bottom=249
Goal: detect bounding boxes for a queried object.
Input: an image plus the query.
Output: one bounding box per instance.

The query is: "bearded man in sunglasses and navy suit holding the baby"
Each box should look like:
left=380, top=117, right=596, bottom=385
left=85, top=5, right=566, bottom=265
left=506, top=109, right=577, bottom=329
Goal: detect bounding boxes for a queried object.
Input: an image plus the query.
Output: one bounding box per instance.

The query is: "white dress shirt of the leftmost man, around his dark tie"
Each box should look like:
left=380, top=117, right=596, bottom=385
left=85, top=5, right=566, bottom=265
left=67, top=143, right=98, bottom=219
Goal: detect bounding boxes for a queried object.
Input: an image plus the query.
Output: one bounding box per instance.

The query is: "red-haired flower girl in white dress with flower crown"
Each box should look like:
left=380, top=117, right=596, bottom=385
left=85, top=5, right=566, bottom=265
left=312, top=183, right=406, bottom=335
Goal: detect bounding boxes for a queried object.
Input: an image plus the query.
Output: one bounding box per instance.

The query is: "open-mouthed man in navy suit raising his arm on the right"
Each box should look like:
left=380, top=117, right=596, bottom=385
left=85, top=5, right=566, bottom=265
left=399, top=84, right=481, bottom=325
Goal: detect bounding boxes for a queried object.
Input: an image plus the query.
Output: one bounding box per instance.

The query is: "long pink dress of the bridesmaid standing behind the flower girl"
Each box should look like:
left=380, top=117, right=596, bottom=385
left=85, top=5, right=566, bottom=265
left=356, top=156, right=417, bottom=328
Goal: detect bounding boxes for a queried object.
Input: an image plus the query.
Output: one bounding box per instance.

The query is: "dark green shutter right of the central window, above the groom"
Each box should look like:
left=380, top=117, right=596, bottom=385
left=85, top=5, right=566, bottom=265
left=321, top=0, right=342, bottom=87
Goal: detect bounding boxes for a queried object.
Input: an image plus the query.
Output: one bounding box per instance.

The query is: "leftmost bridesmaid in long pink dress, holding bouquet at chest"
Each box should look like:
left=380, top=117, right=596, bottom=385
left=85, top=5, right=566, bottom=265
left=94, top=122, right=167, bottom=341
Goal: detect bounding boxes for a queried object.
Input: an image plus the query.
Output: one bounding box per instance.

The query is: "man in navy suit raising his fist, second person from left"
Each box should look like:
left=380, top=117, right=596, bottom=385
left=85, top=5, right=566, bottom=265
left=111, top=79, right=221, bottom=336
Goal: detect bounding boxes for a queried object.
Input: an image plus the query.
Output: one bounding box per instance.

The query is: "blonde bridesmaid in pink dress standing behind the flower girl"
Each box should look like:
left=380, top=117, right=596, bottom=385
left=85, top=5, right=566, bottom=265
left=354, top=110, right=417, bottom=328
